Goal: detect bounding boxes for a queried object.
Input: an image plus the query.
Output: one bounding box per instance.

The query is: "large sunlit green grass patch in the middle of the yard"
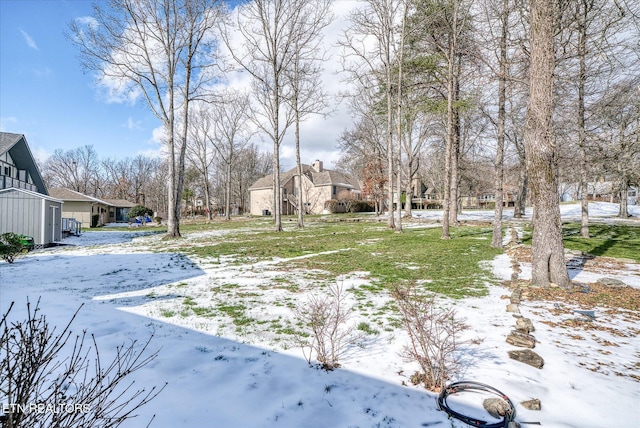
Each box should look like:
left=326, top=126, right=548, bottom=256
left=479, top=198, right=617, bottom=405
left=174, top=221, right=501, bottom=298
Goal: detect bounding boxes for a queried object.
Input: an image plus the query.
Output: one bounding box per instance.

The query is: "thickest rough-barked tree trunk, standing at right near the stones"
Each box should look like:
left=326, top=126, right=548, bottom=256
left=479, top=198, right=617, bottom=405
left=525, top=0, right=571, bottom=287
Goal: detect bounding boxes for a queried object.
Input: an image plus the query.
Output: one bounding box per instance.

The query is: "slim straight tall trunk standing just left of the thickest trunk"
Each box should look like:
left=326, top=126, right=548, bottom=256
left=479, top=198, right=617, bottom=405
left=491, top=0, right=509, bottom=248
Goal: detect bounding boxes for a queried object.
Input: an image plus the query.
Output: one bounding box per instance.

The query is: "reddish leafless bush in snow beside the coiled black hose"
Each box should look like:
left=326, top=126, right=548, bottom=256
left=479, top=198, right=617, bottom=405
left=392, top=284, right=468, bottom=391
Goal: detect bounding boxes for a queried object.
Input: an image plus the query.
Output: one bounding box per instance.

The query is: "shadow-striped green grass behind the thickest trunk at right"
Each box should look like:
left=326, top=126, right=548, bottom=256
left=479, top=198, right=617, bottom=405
left=523, top=223, right=640, bottom=262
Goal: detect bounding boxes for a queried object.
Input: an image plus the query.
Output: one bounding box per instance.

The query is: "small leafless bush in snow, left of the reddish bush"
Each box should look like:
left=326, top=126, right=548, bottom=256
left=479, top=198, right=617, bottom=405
left=293, top=283, right=358, bottom=370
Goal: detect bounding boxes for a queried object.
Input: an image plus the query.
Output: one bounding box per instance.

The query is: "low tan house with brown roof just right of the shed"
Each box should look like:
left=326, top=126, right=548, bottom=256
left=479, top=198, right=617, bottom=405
left=50, top=187, right=135, bottom=228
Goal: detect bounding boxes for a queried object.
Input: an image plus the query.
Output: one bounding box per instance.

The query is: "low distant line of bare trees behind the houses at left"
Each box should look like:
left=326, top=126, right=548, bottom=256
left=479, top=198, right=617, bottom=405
left=42, top=144, right=271, bottom=219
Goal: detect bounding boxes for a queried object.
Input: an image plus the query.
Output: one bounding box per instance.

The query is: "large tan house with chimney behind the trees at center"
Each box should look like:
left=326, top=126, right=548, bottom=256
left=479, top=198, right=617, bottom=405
left=249, top=160, right=360, bottom=215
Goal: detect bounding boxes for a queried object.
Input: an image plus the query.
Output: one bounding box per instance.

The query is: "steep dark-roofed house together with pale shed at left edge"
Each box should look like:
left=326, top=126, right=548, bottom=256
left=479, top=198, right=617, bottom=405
left=0, top=132, right=63, bottom=247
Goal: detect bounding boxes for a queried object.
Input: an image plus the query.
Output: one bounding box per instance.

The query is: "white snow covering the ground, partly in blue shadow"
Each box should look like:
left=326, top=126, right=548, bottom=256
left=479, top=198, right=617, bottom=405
left=0, top=204, right=640, bottom=428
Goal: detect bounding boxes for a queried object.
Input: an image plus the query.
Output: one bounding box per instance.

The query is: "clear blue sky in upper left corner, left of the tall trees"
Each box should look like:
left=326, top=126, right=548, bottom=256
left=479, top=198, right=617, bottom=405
left=0, top=0, right=160, bottom=160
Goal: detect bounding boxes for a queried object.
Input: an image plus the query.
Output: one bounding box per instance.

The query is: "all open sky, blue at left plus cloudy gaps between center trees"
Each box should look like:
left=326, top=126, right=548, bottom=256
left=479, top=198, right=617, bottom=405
left=0, top=0, right=354, bottom=170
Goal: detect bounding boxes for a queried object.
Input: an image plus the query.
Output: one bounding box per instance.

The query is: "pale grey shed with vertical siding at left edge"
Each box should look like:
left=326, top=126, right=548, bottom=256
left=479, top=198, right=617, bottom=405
left=0, top=188, right=62, bottom=246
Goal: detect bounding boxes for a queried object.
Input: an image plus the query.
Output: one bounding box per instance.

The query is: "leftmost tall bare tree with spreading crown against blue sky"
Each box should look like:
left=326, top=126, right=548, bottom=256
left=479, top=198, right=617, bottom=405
left=70, top=0, right=224, bottom=237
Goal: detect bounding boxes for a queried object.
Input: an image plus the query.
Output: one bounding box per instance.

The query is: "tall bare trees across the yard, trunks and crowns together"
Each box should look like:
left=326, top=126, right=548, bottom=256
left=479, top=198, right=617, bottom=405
left=61, top=0, right=640, bottom=285
